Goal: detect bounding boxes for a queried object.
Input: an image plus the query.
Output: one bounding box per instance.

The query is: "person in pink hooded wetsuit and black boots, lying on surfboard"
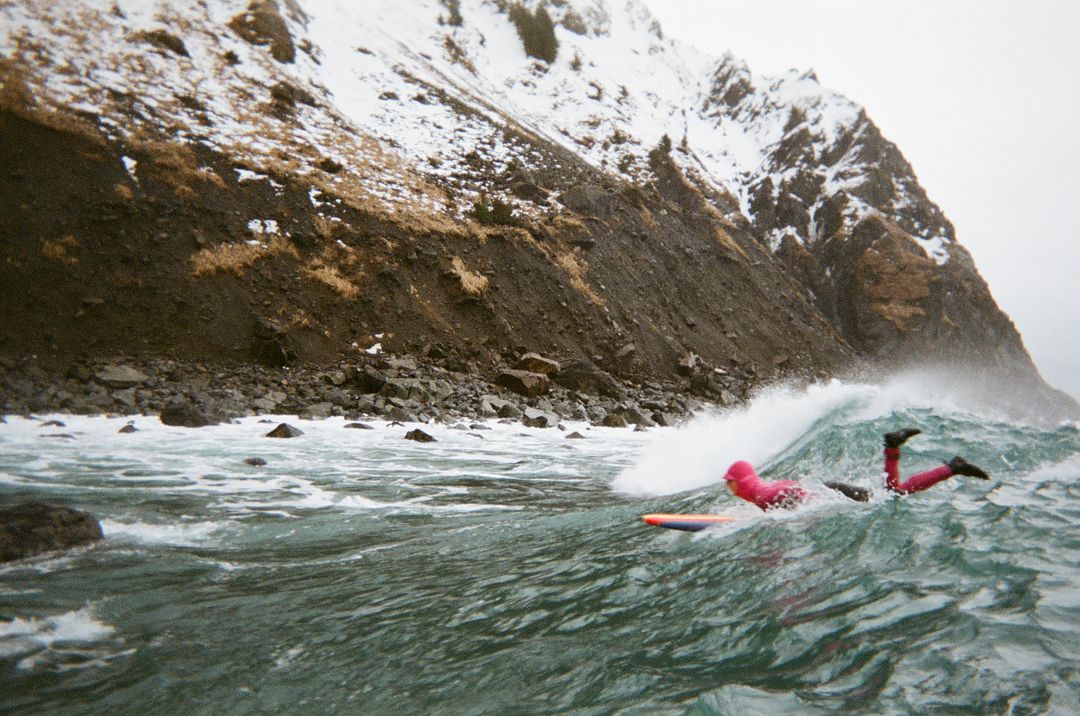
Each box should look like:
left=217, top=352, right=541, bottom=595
left=724, top=428, right=989, bottom=510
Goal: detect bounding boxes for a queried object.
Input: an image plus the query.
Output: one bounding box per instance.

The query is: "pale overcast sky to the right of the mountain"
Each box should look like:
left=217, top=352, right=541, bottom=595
left=646, top=0, right=1080, bottom=397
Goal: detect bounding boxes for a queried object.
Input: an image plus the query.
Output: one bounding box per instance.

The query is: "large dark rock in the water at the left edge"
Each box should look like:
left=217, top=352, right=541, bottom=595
left=0, top=502, right=103, bottom=562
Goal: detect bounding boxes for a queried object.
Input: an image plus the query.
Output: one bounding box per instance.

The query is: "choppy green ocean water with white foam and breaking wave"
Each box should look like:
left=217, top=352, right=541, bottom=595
left=0, top=381, right=1080, bottom=715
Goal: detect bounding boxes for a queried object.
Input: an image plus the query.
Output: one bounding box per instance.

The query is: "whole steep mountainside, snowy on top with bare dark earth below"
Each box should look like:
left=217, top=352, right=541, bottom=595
left=0, top=0, right=1067, bottom=412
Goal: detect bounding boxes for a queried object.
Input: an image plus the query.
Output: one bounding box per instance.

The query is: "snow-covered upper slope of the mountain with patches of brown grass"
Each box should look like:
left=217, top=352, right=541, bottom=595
left=0, top=0, right=951, bottom=264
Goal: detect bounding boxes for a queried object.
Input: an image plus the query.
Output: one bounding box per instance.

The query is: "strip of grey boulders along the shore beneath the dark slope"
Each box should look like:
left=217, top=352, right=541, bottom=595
left=0, top=353, right=752, bottom=429
